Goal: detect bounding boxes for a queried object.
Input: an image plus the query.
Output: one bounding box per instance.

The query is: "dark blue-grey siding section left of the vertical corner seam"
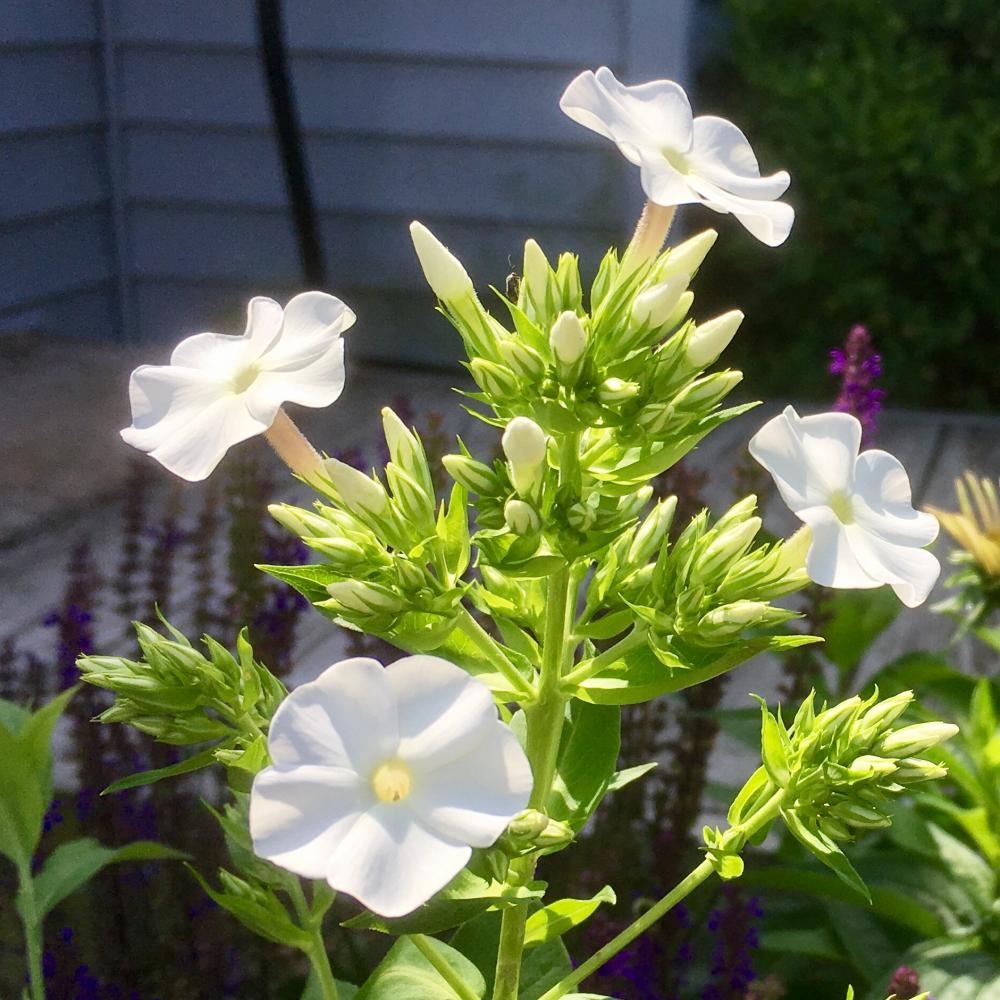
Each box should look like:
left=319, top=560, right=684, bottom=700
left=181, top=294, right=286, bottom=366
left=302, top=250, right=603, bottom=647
left=0, top=0, right=119, bottom=337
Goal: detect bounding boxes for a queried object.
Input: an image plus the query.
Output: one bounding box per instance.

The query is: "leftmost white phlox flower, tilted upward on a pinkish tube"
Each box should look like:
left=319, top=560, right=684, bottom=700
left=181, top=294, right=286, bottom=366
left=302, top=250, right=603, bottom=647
left=121, top=292, right=356, bottom=481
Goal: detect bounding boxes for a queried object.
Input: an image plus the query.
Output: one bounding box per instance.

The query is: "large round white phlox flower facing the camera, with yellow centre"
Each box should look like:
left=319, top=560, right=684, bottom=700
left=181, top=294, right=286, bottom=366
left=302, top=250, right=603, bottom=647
left=250, top=655, right=532, bottom=917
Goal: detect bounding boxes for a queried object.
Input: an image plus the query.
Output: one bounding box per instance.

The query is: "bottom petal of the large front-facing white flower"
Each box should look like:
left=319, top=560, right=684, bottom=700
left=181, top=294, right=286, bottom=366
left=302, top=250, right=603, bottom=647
left=326, top=803, right=472, bottom=917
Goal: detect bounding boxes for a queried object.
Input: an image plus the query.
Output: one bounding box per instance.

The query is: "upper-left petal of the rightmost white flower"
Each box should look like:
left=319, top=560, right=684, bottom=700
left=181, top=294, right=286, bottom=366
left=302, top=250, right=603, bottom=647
left=749, top=406, right=861, bottom=516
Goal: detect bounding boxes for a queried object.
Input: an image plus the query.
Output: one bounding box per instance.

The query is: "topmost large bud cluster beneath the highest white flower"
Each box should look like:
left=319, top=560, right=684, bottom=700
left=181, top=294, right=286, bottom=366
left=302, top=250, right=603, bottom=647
left=411, top=223, right=743, bottom=498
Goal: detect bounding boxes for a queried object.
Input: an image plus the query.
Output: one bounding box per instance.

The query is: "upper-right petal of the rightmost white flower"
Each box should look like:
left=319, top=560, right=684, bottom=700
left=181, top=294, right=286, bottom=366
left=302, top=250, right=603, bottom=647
left=854, top=449, right=939, bottom=547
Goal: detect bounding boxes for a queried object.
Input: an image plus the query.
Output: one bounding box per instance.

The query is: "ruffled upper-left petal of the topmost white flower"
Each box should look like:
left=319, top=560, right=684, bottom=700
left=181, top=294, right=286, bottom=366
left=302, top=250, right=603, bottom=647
left=559, top=66, right=692, bottom=163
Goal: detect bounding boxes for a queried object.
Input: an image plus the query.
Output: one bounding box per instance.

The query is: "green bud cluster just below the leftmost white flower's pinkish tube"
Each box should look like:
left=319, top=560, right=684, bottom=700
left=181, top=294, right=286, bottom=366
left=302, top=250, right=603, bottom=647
left=265, top=407, right=469, bottom=636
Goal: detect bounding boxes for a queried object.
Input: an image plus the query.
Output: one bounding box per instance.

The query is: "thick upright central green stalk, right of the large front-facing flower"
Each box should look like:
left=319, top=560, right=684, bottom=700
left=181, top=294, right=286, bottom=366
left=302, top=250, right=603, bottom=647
left=493, top=566, right=575, bottom=1000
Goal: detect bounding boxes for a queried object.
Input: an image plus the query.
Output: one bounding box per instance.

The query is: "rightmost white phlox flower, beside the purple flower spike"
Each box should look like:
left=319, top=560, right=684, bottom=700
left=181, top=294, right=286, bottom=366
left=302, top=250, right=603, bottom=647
left=750, top=406, right=941, bottom=607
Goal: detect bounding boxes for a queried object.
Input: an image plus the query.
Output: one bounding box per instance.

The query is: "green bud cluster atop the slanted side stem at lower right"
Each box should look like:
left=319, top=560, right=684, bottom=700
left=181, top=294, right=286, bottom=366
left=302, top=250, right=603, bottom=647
left=705, top=691, right=958, bottom=895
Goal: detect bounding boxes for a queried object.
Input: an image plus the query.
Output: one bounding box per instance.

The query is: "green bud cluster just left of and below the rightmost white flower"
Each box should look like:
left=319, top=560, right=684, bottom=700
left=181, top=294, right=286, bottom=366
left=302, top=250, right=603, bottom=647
left=587, top=496, right=809, bottom=666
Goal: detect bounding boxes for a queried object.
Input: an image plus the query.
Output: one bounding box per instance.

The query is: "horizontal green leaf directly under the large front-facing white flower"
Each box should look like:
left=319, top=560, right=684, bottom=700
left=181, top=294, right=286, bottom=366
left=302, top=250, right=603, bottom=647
left=342, top=870, right=543, bottom=936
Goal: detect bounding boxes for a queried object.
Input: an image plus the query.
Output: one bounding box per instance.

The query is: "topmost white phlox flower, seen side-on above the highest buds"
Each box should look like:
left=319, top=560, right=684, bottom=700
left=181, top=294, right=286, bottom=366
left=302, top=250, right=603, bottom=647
left=559, top=66, right=795, bottom=246
